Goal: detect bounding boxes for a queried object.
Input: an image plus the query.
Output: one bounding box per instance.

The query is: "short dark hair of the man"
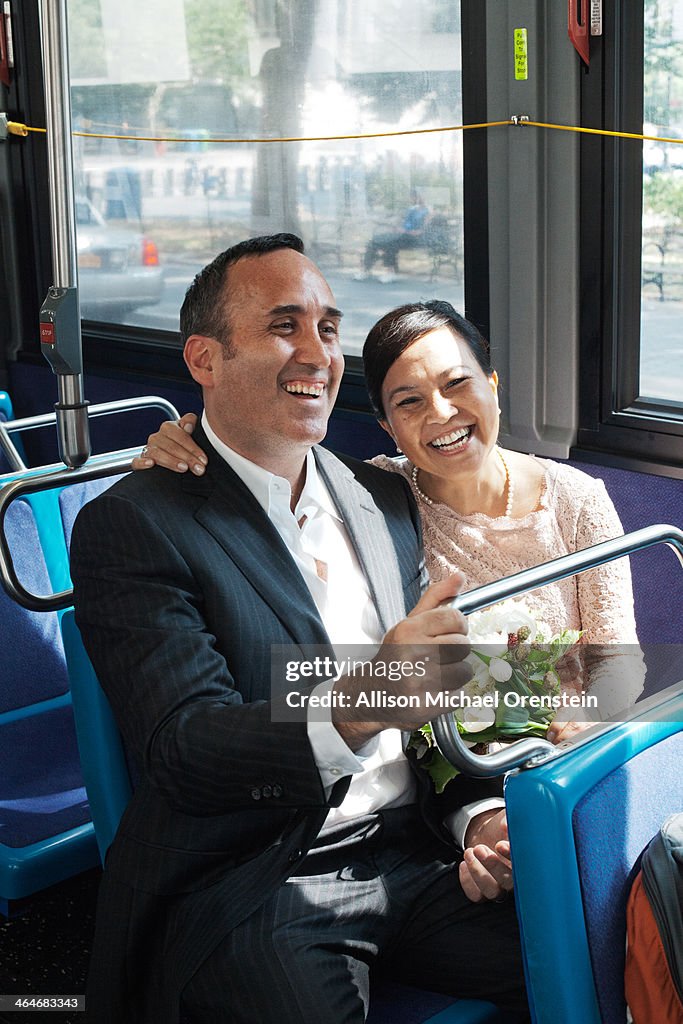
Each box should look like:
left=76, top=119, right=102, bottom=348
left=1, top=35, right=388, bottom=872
left=180, top=231, right=303, bottom=348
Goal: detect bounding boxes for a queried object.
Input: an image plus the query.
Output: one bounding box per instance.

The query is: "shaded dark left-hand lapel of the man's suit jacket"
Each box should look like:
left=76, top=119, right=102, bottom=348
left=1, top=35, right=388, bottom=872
left=183, top=428, right=330, bottom=645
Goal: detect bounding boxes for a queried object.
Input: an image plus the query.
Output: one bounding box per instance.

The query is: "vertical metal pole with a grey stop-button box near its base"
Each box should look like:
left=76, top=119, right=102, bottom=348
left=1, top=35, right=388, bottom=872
left=40, top=0, right=90, bottom=467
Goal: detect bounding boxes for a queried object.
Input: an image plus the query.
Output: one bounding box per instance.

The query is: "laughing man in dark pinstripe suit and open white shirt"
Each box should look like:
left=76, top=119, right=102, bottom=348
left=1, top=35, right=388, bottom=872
left=72, top=236, right=525, bottom=1024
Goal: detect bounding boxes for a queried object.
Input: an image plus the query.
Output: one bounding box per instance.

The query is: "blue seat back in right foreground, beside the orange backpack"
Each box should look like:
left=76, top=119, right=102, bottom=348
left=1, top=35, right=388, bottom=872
left=505, top=683, right=683, bottom=1024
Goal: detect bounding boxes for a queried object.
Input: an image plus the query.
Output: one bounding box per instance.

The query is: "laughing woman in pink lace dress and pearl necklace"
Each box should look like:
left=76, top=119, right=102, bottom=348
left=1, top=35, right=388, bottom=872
left=134, top=300, right=644, bottom=742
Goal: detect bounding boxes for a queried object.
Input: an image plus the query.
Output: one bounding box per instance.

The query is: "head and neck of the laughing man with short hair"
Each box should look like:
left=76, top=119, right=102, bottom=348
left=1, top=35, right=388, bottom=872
left=180, top=240, right=344, bottom=495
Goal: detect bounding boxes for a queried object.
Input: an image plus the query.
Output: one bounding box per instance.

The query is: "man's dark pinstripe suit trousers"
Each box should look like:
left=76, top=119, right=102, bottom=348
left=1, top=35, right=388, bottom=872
left=182, top=807, right=524, bottom=1024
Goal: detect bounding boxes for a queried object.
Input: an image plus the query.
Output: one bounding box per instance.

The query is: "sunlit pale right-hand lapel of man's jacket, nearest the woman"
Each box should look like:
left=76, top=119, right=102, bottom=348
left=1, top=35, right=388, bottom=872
left=313, top=446, right=405, bottom=633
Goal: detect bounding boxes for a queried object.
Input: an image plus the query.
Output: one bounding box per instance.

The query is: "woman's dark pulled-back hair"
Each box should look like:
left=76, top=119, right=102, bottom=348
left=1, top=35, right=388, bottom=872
left=362, top=299, right=493, bottom=420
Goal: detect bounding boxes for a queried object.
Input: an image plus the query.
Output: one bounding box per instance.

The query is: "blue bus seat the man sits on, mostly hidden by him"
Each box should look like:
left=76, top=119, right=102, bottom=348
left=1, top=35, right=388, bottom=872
left=61, top=608, right=509, bottom=1024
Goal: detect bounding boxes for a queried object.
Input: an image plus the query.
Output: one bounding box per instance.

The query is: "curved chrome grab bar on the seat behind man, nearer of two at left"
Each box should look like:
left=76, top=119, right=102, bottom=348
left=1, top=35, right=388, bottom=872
left=0, top=449, right=139, bottom=611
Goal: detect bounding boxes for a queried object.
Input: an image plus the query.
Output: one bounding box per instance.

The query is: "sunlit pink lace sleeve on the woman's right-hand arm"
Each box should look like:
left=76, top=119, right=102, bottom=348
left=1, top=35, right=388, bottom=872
left=575, top=480, right=645, bottom=718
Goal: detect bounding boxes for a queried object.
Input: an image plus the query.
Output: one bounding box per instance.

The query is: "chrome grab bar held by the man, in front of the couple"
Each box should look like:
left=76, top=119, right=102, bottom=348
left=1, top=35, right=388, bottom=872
left=431, top=524, right=683, bottom=778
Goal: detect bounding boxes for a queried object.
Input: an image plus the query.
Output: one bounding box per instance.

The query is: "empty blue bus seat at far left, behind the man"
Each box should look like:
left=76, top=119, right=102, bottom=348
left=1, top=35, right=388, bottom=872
left=0, top=500, right=97, bottom=915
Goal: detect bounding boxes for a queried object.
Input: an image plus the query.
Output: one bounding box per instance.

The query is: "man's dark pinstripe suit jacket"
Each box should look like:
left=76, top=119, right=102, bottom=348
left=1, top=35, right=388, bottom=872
left=72, top=419, right=499, bottom=1024
